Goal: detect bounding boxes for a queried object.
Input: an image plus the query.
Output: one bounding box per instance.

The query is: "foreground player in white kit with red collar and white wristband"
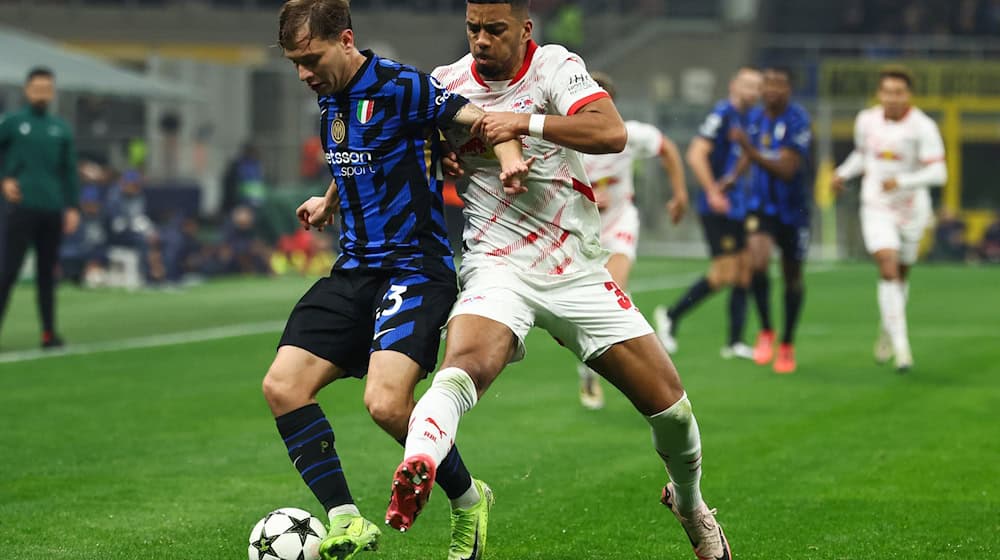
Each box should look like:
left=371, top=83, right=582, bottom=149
left=386, top=0, right=731, bottom=560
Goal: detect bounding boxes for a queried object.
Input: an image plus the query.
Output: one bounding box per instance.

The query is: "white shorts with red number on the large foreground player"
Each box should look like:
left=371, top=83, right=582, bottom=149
left=449, top=258, right=653, bottom=362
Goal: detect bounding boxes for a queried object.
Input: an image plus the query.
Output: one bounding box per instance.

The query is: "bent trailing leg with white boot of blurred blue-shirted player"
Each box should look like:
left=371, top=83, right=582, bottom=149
left=653, top=214, right=724, bottom=354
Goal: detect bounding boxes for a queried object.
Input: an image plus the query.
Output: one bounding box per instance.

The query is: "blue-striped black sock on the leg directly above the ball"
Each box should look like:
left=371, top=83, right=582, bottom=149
left=275, top=404, right=354, bottom=512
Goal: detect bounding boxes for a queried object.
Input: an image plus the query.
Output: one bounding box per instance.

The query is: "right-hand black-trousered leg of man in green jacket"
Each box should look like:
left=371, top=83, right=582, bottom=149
left=35, top=212, right=63, bottom=348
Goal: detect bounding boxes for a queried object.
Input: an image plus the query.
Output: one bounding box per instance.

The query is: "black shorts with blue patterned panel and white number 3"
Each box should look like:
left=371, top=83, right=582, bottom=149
left=278, top=267, right=458, bottom=377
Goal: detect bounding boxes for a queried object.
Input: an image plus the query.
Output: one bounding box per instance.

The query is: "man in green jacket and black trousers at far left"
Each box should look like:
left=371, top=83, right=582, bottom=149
left=0, top=68, right=80, bottom=348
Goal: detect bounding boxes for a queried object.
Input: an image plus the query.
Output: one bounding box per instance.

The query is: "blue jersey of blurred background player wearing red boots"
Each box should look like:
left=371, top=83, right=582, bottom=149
left=747, top=103, right=812, bottom=226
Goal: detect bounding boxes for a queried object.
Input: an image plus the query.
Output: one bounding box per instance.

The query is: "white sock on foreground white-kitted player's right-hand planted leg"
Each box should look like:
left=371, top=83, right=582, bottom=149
left=646, top=393, right=702, bottom=513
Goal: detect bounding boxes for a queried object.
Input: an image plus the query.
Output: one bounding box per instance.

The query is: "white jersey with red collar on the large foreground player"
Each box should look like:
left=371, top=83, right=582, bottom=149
left=432, top=41, right=608, bottom=275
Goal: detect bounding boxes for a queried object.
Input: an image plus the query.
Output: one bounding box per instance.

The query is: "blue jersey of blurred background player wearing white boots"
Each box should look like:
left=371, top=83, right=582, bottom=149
left=697, top=100, right=749, bottom=220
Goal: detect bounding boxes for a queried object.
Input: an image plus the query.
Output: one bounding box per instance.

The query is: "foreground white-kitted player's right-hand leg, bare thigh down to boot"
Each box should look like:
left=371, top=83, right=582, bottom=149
left=589, top=335, right=731, bottom=560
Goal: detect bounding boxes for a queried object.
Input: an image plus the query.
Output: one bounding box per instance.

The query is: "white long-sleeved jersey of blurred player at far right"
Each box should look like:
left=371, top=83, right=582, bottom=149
left=854, top=105, right=944, bottom=211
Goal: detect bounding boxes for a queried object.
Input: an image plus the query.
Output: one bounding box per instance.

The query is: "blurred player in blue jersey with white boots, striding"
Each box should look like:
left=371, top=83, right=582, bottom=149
left=653, top=68, right=761, bottom=359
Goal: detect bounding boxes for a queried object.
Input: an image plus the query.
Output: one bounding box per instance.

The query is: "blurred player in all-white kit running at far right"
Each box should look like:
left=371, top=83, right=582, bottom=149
left=833, top=66, right=948, bottom=372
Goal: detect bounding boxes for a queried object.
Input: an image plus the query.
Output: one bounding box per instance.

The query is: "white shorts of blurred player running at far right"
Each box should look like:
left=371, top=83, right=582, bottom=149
left=861, top=205, right=930, bottom=265
